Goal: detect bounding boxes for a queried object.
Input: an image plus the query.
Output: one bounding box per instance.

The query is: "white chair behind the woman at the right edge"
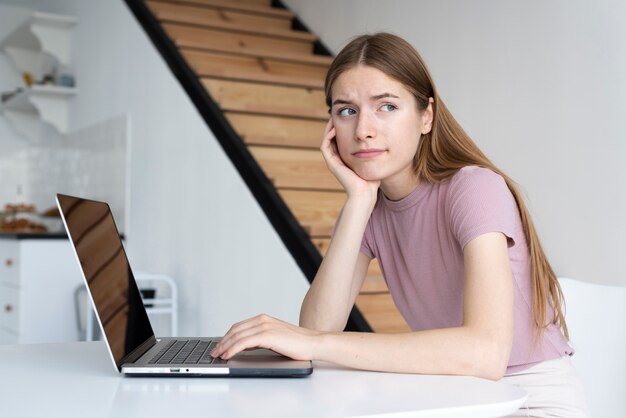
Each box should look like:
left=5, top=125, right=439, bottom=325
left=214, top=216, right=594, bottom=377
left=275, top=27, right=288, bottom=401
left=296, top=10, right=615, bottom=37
left=559, top=278, right=626, bottom=418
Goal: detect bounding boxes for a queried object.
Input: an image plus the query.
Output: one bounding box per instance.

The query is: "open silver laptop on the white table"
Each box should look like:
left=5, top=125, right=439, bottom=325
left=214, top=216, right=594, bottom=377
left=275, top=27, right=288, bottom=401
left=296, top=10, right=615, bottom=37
left=57, top=194, right=313, bottom=377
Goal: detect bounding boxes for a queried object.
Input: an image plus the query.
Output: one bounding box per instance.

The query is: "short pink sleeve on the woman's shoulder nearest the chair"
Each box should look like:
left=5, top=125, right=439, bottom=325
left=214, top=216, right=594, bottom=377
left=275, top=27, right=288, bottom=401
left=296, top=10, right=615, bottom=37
left=447, top=167, right=520, bottom=248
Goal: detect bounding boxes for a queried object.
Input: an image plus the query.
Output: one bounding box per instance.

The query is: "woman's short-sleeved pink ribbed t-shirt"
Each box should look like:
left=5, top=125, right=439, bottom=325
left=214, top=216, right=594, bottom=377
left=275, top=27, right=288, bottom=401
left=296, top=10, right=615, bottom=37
left=361, top=167, right=573, bottom=373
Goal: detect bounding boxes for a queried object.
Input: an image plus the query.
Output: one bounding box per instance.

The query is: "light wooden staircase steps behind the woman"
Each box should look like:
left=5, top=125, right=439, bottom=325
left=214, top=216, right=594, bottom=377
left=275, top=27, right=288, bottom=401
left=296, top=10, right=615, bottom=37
left=127, top=0, right=408, bottom=332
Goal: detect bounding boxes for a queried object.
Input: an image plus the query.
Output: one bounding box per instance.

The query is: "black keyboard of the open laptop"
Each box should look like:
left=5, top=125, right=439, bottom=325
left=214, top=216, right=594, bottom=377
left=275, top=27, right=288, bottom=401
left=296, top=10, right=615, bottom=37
left=148, top=340, right=226, bottom=364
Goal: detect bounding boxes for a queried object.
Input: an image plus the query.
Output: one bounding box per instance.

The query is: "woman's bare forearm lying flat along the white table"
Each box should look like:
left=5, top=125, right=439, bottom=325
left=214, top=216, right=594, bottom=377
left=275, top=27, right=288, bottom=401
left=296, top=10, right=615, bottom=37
left=314, top=326, right=511, bottom=380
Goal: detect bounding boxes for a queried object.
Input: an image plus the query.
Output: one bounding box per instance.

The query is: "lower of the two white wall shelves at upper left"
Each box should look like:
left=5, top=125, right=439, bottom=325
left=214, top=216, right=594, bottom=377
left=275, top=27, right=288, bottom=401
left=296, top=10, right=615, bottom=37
left=0, top=85, right=78, bottom=140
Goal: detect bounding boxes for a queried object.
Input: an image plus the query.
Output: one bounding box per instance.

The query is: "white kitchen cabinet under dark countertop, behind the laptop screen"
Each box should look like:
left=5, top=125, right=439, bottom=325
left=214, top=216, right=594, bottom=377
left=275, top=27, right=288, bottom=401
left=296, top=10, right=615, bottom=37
left=0, top=234, right=83, bottom=344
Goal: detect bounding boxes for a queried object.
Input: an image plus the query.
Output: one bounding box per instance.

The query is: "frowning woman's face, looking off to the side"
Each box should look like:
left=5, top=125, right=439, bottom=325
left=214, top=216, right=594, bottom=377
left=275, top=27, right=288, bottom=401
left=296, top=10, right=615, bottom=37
left=331, top=65, right=432, bottom=189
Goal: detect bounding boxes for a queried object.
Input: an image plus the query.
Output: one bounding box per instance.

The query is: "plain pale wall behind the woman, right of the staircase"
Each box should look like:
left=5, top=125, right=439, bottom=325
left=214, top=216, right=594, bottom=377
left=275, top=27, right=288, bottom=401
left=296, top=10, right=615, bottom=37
left=285, top=0, right=626, bottom=284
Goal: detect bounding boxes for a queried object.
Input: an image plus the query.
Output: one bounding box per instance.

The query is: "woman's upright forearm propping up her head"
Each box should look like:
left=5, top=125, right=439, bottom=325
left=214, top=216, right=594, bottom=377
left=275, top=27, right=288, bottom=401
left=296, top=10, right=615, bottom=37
left=300, top=199, right=375, bottom=331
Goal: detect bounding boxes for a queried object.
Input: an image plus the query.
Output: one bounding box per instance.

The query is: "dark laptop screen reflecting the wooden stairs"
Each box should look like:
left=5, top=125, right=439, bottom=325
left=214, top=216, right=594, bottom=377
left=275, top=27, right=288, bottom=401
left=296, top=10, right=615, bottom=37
left=57, top=194, right=154, bottom=367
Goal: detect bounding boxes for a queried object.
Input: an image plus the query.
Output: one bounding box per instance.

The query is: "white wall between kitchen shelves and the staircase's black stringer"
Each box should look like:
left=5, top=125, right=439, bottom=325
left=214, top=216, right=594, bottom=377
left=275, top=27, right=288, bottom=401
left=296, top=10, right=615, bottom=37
left=0, top=0, right=308, bottom=335
